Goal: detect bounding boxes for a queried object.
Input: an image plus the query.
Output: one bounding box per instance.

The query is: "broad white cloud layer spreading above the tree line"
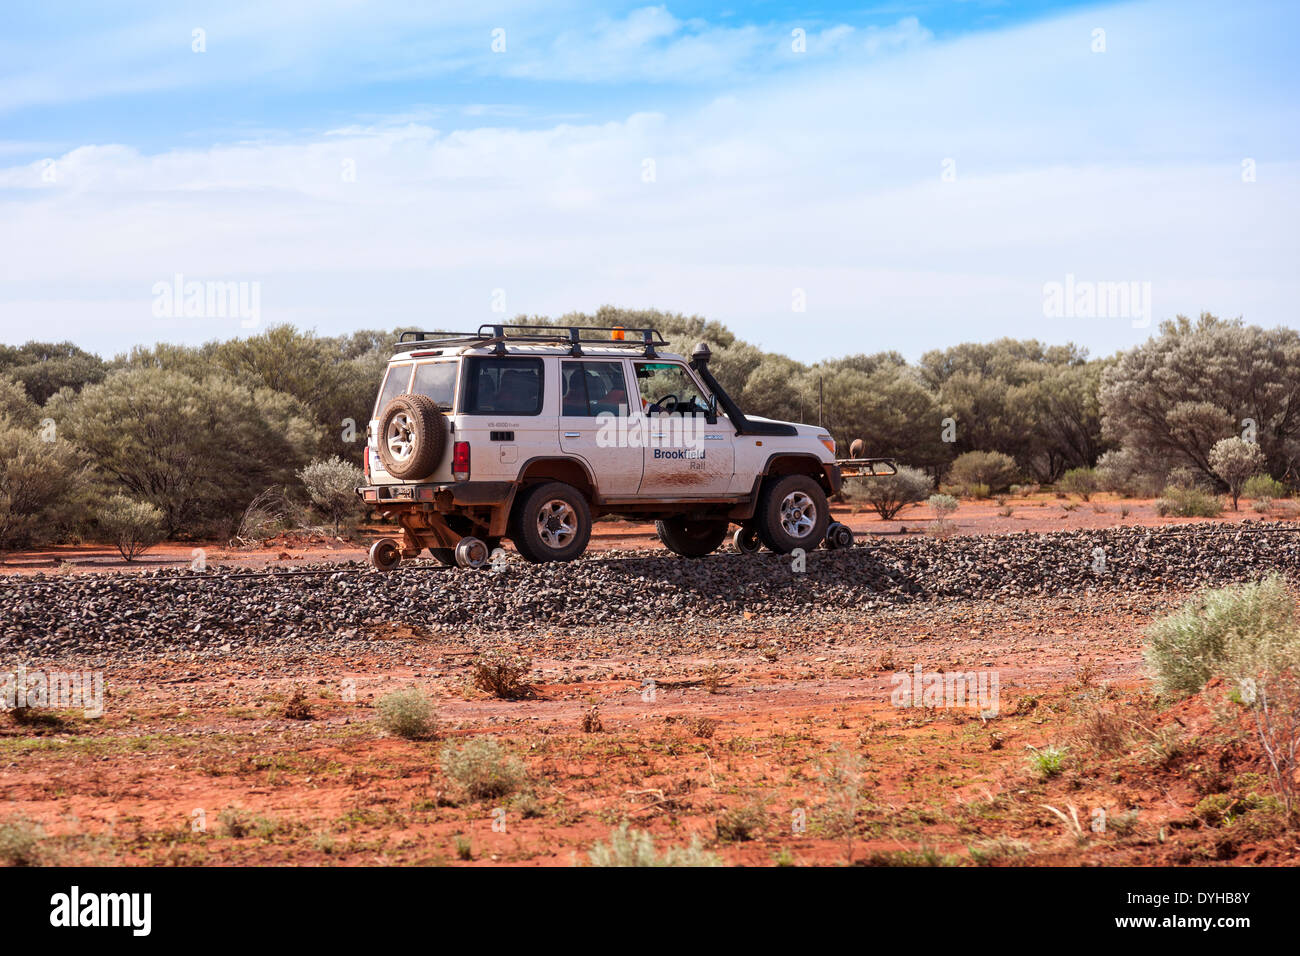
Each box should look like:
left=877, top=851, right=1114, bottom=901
left=0, top=0, right=1300, bottom=359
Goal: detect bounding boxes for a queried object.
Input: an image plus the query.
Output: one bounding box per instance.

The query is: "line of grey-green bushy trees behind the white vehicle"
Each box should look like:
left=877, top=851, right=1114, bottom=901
left=0, top=307, right=1300, bottom=549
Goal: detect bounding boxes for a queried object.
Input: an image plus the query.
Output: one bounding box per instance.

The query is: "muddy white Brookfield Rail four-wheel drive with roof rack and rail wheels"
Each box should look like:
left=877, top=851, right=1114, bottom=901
left=358, top=325, right=893, bottom=570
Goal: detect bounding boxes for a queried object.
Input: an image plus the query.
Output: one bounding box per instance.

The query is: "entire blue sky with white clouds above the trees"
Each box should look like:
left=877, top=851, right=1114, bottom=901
left=0, top=0, right=1300, bottom=360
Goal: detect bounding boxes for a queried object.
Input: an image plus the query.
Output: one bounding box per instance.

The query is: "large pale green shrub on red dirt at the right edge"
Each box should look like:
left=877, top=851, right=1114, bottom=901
left=1144, top=575, right=1295, bottom=693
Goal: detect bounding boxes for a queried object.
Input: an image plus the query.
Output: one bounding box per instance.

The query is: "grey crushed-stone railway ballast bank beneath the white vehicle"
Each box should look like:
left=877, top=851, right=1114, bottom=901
left=0, top=523, right=1300, bottom=657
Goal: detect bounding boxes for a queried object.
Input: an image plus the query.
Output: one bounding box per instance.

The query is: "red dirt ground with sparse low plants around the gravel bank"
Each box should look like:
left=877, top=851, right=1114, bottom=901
left=0, top=496, right=1300, bottom=865
